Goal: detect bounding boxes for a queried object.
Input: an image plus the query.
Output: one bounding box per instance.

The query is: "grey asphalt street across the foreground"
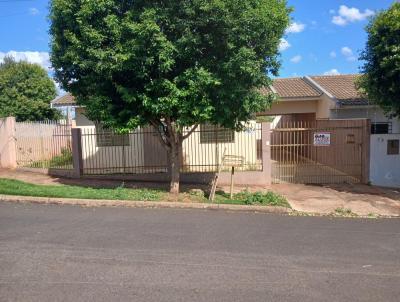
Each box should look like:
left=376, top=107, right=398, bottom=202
left=0, top=203, right=400, bottom=302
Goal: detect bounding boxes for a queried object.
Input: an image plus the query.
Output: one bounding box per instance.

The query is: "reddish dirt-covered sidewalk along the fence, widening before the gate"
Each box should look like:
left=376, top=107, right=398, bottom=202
left=0, top=169, right=400, bottom=216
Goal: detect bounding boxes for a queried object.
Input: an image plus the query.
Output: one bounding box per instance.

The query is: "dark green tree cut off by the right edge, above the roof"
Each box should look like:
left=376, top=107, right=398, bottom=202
left=358, top=3, right=400, bottom=116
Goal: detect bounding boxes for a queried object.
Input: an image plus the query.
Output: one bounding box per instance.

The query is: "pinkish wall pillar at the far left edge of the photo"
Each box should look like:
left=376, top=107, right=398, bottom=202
left=0, top=117, right=17, bottom=169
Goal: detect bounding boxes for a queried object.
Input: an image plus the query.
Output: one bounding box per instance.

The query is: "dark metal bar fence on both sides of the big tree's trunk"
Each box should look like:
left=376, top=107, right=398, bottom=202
left=81, top=123, right=262, bottom=175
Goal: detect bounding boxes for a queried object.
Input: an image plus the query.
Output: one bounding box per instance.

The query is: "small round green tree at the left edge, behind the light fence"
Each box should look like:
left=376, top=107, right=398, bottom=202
left=0, top=57, right=60, bottom=121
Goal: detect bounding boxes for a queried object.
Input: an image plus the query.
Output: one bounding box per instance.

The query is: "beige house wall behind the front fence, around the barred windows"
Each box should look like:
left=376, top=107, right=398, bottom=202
left=76, top=108, right=261, bottom=174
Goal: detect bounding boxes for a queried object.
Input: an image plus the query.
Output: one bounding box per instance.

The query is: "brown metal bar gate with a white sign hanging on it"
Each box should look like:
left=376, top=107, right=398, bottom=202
left=271, top=120, right=370, bottom=184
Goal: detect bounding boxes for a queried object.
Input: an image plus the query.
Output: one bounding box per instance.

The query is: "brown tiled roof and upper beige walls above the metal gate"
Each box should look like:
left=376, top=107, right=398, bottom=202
left=259, top=75, right=400, bottom=134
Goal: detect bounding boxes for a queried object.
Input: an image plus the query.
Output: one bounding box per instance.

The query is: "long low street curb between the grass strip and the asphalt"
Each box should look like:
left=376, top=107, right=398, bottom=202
left=0, top=195, right=293, bottom=214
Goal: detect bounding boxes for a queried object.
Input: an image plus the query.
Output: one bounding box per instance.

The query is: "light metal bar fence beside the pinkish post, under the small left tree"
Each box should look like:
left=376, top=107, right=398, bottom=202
left=15, top=121, right=73, bottom=170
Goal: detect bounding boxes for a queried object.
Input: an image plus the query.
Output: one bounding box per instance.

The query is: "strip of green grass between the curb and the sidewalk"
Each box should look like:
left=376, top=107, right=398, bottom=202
left=0, top=178, right=290, bottom=208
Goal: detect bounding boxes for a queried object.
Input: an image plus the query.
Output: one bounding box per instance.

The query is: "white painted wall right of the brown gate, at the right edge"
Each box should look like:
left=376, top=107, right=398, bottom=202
left=370, top=134, right=400, bottom=188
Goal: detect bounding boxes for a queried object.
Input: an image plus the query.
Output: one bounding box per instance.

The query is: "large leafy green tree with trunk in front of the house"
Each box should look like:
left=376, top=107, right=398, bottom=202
left=50, top=0, right=290, bottom=193
